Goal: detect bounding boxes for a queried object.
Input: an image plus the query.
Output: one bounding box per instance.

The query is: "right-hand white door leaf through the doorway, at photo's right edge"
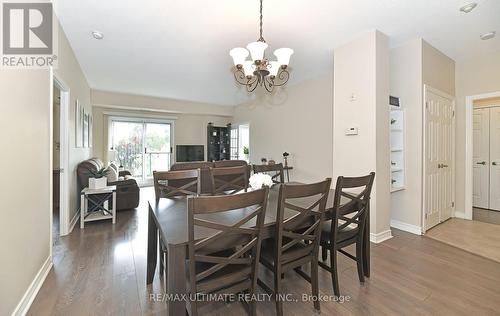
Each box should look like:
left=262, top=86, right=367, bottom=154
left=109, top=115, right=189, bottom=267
left=485, top=107, right=500, bottom=210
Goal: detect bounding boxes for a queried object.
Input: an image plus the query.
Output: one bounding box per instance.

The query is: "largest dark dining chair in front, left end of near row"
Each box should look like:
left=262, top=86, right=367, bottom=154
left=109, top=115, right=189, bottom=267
left=187, top=188, right=269, bottom=315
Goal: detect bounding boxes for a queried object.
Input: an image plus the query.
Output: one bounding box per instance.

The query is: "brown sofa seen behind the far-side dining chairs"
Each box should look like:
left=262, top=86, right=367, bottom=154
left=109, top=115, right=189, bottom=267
left=170, top=160, right=250, bottom=194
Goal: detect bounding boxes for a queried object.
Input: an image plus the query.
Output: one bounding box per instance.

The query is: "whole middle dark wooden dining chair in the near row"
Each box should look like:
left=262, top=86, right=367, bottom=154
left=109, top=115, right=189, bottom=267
left=258, top=178, right=331, bottom=315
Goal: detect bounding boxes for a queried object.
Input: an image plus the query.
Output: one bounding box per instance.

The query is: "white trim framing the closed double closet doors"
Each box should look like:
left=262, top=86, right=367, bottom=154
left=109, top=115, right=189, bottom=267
left=421, top=84, right=456, bottom=234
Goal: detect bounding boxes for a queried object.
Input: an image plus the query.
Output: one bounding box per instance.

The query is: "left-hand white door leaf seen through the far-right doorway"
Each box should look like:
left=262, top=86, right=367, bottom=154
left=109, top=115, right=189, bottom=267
left=472, top=108, right=488, bottom=208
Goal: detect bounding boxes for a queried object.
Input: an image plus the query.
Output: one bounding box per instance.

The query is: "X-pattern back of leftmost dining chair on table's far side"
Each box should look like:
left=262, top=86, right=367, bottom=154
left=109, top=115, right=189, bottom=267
left=153, top=169, right=201, bottom=200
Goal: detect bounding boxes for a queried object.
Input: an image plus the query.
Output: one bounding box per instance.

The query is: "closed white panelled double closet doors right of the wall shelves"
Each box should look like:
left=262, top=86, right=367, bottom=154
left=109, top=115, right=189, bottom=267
left=424, top=87, right=455, bottom=229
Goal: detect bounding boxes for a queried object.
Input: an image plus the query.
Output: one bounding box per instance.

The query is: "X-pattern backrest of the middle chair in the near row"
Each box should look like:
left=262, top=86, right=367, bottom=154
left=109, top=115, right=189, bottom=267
left=275, top=178, right=331, bottom=264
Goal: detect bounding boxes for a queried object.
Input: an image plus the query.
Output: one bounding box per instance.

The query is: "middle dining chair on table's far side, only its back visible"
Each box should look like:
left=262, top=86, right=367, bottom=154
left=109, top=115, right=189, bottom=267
left=210, top=165, right=250, bottom=195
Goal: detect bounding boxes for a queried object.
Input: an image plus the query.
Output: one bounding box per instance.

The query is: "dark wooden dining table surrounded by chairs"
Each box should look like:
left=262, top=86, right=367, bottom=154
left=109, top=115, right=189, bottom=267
left=146, top=182, right=370, bottom=315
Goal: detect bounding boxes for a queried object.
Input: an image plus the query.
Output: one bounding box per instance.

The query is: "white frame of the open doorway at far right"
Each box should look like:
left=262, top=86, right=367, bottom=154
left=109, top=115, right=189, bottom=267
left=464, top=91, right=500, bottom=220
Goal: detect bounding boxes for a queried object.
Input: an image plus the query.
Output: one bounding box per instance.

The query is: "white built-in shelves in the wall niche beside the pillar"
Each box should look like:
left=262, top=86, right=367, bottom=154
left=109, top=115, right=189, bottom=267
left=390, top=106, right=405, bottom=192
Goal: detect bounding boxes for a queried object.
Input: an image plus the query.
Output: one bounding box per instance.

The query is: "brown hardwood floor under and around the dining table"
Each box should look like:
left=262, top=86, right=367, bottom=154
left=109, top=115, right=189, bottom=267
left=29, top=188, right=500, bottom=316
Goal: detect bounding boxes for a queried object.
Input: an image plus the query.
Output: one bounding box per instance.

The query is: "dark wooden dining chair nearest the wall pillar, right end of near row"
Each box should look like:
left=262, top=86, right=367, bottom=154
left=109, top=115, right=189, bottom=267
left=319, top=172, right=375, bottom=296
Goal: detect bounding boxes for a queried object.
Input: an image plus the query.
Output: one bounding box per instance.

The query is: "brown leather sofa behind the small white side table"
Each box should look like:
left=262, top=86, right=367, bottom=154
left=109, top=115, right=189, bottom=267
left=77, top=158, right=139, bottom=211
